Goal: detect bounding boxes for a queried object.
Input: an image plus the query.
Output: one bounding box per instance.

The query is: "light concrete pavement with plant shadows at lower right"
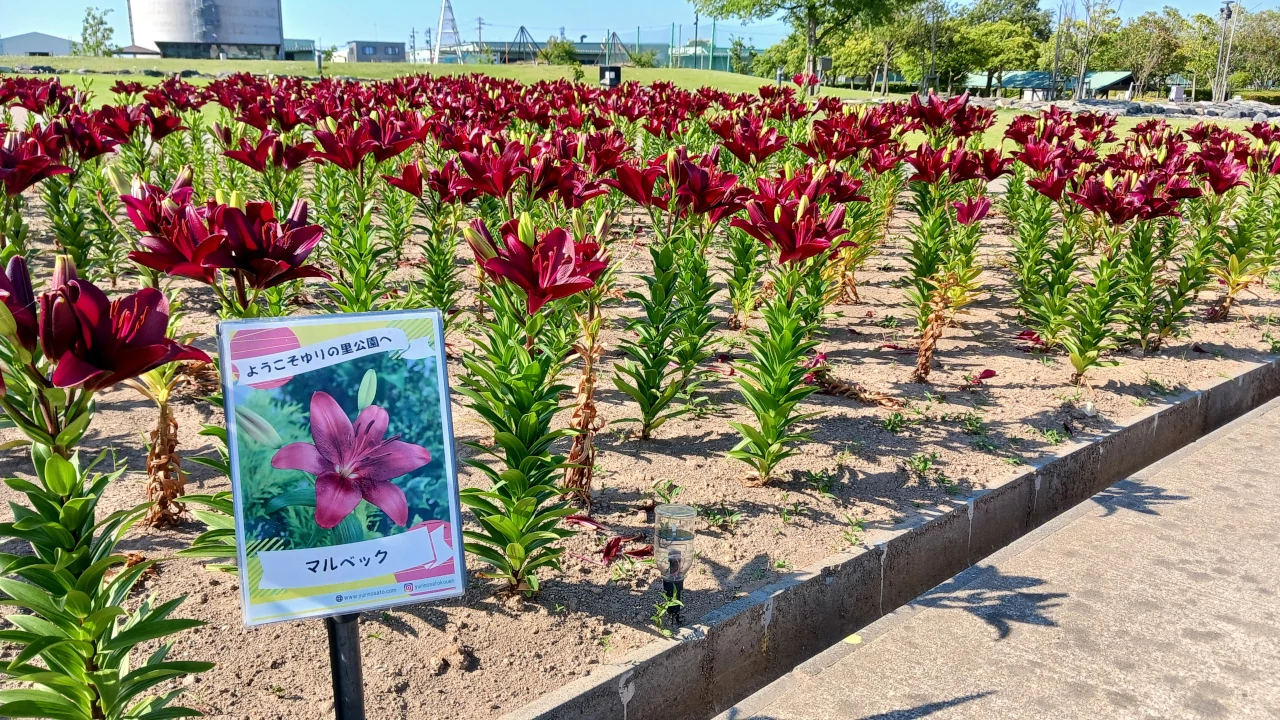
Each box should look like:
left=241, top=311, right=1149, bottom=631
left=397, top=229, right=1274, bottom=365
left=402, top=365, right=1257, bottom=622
left=716, top=401, right=1280, bottom=720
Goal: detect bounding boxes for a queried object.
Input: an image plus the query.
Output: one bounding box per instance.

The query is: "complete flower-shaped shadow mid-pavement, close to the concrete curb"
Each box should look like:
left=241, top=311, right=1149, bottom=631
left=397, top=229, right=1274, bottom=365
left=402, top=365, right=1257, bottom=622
left=913, top=565, right=1069, bottom=639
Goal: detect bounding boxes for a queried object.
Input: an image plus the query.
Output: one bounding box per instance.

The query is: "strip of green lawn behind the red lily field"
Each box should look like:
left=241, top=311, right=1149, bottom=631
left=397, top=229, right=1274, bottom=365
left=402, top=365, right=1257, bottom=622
left=0, top=56, right=870, bottom=97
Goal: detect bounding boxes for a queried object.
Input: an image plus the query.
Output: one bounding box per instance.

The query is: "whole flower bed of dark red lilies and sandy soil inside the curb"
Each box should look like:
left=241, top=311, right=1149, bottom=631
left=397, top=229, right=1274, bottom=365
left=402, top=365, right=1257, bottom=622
left=0, top=77, right=1280, bottom=717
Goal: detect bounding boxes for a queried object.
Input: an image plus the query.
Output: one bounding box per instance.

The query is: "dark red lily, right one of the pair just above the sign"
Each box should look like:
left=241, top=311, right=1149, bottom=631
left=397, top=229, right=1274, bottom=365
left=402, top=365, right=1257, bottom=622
left=202, top=200, right=332, bottom=290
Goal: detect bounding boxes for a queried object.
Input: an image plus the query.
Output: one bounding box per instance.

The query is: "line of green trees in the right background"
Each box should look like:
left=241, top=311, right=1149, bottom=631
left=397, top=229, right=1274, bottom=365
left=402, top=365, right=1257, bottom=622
left=695, top=0, right=1280, bottom=99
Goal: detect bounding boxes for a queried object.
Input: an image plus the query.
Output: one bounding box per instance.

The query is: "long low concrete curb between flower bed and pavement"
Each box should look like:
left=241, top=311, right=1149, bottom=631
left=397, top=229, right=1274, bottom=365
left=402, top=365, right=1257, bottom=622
left=502, top=361, right=1280, bottom=720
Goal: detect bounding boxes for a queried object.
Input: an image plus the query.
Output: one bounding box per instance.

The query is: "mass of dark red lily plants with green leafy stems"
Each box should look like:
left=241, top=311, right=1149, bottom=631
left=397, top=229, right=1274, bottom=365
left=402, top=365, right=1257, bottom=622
left=0, top=74, right=1280, bottom=719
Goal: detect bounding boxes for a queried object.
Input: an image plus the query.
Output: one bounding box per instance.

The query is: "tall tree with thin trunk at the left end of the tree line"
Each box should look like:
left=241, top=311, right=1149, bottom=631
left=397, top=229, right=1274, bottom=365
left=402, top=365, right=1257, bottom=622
left=694, top=0, right=896, bottom=90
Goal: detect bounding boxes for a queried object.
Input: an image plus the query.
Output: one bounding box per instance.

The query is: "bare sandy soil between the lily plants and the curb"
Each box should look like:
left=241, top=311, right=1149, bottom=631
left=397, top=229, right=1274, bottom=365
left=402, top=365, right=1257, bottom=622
left=0, top=196, right=1280, bottom=720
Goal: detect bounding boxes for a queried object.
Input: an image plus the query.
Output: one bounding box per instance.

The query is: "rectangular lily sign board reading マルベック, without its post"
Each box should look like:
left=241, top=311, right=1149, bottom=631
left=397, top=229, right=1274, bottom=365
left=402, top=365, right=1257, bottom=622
left=219, top=310, right=466, bottom=625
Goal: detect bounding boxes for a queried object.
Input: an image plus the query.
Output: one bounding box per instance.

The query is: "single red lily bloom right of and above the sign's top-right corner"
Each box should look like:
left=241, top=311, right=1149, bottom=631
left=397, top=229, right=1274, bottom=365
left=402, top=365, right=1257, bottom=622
left=484, top=219, right=595, bottom=315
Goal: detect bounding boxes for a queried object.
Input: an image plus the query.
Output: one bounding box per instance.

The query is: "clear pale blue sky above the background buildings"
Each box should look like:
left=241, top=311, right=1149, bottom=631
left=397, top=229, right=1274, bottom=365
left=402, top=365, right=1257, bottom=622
left=0, top=0, right=1239, bottom=49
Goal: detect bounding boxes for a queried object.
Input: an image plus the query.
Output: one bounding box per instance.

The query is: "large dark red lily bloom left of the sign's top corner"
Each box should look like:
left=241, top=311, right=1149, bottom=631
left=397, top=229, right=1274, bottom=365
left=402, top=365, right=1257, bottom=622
left=40, top=269, right=209, bottom=392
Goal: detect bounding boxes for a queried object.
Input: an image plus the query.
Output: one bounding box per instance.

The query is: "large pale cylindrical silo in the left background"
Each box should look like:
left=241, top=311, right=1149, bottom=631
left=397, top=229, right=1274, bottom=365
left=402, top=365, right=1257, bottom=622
left=129, top=0, right=284, bottom=59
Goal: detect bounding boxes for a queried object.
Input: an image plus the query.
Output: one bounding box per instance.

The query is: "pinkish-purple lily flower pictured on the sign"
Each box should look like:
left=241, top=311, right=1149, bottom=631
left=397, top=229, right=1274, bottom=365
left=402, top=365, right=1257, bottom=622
left=271, top=391, right=431, bottom=528
